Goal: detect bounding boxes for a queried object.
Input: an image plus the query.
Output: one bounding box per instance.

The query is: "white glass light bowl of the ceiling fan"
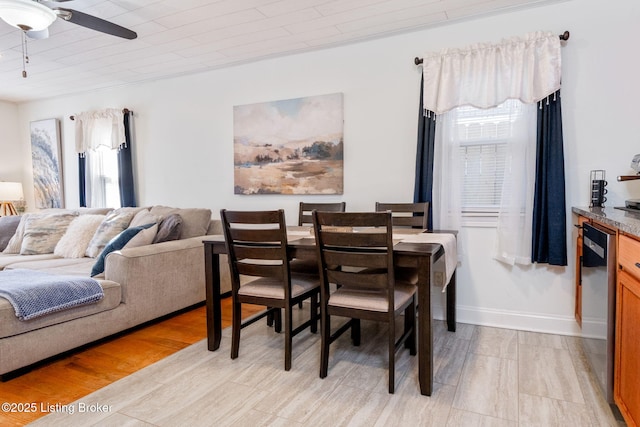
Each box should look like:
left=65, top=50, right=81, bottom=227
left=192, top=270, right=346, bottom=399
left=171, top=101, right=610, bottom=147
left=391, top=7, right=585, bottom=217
left=0, top=0, right=57, bottom=31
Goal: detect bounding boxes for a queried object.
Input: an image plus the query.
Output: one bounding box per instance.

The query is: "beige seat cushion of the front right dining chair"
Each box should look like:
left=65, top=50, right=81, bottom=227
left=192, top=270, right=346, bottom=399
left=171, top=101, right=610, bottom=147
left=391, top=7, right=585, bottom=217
left=328, top=282, right=416, bottom=312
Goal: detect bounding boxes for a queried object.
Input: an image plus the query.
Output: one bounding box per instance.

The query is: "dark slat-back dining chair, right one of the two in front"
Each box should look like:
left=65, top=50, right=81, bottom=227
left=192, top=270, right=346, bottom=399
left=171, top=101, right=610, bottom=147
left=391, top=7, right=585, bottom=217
left=313, top=211, right=416, bottom=393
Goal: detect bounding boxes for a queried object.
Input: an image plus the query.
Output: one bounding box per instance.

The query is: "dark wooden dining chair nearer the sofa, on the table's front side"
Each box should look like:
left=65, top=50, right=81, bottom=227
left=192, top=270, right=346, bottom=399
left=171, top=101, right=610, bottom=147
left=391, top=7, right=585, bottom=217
left=220, top=209, right=320, bottom=371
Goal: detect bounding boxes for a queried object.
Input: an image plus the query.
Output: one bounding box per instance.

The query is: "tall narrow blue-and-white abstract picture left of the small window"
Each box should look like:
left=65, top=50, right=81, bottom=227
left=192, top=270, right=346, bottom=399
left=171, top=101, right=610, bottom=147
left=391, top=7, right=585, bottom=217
left=31, top=119, right=64, bottom=209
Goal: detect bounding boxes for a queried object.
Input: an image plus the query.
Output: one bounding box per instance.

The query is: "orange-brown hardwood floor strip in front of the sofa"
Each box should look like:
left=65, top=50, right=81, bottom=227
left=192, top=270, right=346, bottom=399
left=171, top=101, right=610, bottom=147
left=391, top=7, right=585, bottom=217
left=0, top=298, right=262, bottom=426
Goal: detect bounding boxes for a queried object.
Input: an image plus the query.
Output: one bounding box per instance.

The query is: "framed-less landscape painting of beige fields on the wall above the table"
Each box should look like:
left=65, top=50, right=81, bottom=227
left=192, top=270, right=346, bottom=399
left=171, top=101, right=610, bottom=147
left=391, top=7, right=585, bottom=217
left=233, top=93, right=344, bottom=194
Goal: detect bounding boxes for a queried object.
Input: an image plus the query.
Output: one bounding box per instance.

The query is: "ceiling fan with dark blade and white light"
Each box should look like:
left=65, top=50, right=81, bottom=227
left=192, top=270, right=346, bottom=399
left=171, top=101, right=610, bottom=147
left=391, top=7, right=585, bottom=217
left=0, top=0, right=138, bottom=40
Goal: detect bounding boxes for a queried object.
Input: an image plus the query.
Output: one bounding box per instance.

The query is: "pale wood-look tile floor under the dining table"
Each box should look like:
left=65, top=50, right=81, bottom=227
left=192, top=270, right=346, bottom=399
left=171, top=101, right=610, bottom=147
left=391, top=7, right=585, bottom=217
left=32, top=310, right=624, bottom=427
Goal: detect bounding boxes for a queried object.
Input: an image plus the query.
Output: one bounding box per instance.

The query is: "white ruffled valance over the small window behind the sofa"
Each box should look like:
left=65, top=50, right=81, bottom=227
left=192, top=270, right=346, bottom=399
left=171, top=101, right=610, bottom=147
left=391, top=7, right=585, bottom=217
left=74, top=108, right=126, bottom=154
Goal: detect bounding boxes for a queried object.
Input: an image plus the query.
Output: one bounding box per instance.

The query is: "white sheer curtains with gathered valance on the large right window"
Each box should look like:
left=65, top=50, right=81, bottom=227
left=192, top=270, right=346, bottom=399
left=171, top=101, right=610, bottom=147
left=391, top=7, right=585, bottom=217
left=423, top=32, right=561, bottom=264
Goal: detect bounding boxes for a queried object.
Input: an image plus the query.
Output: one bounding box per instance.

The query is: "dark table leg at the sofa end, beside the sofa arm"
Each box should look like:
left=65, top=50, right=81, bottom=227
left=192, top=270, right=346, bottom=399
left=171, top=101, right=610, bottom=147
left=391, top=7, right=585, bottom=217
left=204, top=244, right=222, bottom=351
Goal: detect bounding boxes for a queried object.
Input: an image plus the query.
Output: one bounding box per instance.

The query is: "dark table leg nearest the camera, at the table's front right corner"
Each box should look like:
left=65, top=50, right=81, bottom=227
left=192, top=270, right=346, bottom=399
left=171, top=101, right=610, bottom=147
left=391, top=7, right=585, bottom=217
left=418, top=256, right=433, bottom=396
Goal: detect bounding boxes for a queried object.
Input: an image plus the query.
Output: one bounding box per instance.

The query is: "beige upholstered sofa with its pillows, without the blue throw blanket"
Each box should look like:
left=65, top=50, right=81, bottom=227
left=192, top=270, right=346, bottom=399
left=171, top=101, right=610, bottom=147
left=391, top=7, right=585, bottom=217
left=0, top=206, right=231, bottom=380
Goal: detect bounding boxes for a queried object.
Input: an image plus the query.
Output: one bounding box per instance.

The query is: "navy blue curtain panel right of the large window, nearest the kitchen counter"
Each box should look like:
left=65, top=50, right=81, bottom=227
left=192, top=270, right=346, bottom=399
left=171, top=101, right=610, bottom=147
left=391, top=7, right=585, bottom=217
left=531, top=91, right=567, bottom=265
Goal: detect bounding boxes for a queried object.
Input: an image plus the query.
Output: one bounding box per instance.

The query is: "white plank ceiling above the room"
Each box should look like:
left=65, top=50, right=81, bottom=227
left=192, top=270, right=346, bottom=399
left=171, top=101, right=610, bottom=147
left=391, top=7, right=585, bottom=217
left=0, top=0, right=563, bottom=102
